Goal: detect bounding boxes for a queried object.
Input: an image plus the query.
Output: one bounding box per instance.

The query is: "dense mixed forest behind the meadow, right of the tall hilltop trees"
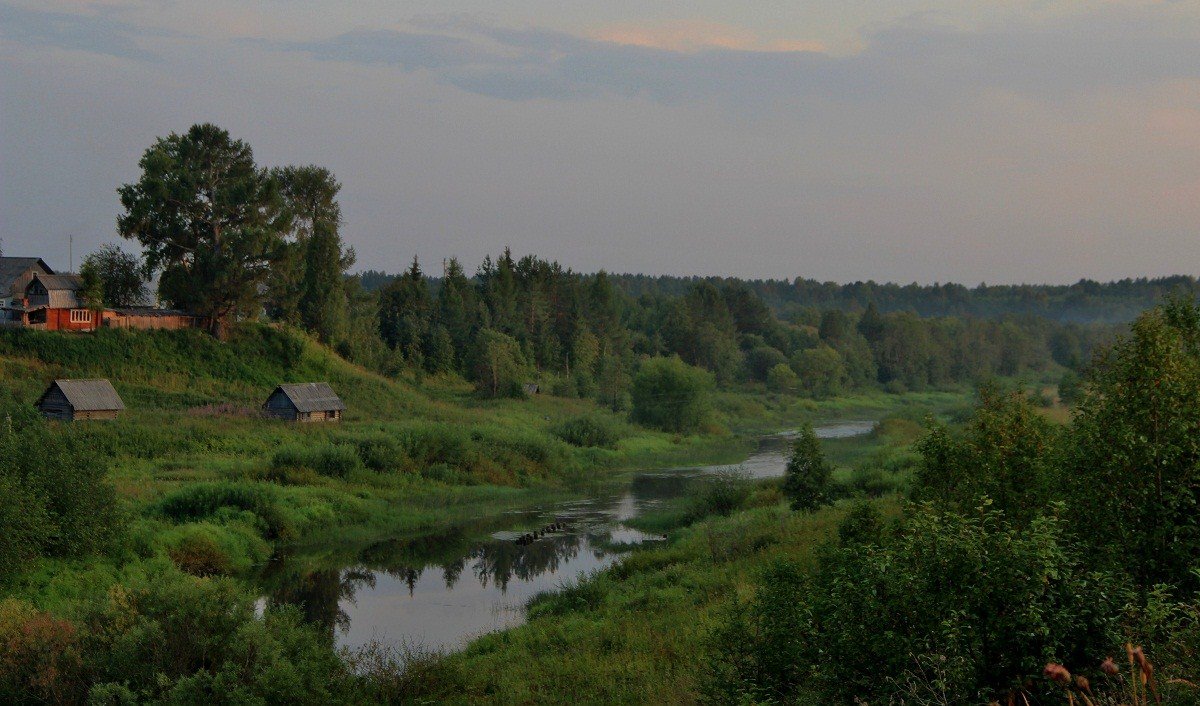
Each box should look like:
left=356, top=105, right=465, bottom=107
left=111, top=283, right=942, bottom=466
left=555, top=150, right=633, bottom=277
left=356, top=251, right=1113, bottom=408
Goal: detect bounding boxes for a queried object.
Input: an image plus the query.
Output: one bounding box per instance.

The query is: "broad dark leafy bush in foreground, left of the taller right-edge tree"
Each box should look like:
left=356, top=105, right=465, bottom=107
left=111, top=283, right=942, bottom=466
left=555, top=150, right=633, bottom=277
left=710, top=505, right=1130, bottom=704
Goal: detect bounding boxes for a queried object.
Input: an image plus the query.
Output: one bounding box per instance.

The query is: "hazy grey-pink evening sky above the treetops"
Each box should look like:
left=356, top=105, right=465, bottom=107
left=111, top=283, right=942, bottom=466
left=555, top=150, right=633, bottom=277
left=0, top=0, right=1200, bottom=285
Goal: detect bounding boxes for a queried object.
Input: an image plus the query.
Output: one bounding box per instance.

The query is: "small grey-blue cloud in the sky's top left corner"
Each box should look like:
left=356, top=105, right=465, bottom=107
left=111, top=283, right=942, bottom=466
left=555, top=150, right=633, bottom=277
left=0, top=4, right=164, bottom=61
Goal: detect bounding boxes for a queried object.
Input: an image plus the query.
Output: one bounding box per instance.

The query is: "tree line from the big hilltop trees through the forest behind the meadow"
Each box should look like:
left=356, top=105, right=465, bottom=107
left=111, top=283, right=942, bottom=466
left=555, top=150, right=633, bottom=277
left=98, top=125, right=1112, bottom=417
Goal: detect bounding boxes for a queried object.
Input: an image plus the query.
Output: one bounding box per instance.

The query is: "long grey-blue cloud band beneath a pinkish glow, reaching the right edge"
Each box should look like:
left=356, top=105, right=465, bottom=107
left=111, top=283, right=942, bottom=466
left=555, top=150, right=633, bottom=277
left=280, top=6, right=1200, bottom=107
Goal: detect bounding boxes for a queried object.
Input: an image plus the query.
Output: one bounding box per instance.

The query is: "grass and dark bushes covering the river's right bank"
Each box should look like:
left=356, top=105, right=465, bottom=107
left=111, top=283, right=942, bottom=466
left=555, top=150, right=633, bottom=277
left=376, top=300, right=1200, bottom=706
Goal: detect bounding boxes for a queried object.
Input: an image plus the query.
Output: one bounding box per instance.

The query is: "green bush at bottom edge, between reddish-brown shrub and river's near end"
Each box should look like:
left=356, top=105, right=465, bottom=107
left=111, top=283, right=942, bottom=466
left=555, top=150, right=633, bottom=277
left=73, top=564, right=360, bottom=704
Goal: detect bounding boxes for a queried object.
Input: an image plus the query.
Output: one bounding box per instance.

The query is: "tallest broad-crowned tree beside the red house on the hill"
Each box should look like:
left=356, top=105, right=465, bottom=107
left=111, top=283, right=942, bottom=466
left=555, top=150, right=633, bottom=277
left=116, top=124, right=289, bottom=335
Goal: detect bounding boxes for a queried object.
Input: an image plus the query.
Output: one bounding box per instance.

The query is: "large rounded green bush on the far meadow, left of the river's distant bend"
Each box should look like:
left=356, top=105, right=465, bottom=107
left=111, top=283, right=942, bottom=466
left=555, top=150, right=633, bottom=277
left=631, top=357, right=713, bottom=433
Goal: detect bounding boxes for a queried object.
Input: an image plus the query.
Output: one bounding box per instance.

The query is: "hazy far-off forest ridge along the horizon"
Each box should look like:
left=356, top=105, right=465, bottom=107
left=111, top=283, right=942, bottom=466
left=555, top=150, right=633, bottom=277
left=360, top=270, right=1200, bottom=323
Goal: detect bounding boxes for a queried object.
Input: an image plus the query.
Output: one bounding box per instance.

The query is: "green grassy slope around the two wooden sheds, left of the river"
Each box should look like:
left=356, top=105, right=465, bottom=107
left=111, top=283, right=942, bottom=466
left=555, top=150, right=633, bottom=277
left=0, top=325, right=740, bottom=568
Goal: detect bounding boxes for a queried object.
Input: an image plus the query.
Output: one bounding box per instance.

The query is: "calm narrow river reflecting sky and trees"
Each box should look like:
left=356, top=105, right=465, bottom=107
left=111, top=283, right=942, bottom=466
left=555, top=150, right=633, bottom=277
left=255, top=421, right=875, bottom=650
